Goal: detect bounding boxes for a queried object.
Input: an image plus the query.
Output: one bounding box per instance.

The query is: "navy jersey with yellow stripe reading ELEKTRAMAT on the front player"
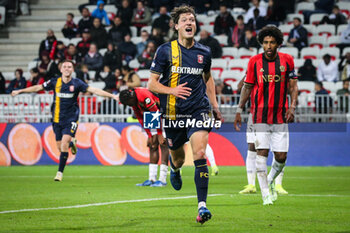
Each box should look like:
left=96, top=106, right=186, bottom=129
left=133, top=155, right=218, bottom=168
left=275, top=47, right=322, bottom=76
left=150, top=40, right=211, bottom=119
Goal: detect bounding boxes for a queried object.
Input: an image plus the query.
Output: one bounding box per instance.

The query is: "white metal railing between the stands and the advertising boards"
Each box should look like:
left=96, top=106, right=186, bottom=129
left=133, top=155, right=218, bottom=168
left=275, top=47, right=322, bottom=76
left=0, top=93, right=350, bottom=123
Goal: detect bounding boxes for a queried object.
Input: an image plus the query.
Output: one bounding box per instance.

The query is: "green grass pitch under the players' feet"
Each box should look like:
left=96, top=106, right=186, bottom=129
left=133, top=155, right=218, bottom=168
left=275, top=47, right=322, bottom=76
left=0, top=165, right=350, bottom=233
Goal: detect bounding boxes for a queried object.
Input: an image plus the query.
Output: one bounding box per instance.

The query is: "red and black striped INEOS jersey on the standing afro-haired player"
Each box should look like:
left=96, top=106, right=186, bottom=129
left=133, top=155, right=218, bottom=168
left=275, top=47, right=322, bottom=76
left=244, top=52, right=298, bottom=124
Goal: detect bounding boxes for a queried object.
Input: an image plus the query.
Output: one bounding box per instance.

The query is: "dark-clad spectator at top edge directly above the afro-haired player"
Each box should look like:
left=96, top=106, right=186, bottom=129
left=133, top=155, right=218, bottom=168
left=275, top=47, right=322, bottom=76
left=265, top=0, right=287, bottom=27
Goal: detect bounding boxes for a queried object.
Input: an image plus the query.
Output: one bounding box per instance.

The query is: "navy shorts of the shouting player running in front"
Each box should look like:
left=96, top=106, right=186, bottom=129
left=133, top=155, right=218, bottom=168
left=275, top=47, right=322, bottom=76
left=163, top=109, right=212, bottom=150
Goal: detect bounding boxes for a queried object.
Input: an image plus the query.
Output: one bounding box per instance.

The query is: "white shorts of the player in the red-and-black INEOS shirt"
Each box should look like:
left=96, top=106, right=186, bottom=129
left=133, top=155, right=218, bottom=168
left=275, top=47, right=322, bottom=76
left=254, top=123, right=289, bottom=152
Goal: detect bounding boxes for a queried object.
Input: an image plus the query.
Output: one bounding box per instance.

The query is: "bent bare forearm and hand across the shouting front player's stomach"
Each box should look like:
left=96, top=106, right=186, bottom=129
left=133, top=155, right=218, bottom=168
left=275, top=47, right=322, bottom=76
left=147, top=72, right=192, bottom=99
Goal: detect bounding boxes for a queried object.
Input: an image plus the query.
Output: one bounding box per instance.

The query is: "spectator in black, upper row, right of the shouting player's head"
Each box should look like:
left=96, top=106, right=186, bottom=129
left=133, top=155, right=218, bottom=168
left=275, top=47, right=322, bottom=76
left=214, top=5, right=236, bottom=36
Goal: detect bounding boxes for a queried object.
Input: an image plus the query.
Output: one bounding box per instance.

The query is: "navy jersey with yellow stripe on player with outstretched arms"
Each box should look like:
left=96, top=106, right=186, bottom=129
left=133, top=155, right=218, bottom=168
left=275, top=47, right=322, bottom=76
left=43, top=77, right=88, bottom=123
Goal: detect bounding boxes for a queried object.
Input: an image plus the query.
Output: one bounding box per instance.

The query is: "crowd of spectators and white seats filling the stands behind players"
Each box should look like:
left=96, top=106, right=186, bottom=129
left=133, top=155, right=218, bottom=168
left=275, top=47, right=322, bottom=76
left=0, top=0, right=350, bottom=113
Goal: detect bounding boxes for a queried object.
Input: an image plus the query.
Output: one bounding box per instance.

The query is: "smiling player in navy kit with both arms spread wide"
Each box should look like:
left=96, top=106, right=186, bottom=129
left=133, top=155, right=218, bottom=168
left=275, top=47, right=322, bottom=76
left=11, top=60, right=117, bottom=181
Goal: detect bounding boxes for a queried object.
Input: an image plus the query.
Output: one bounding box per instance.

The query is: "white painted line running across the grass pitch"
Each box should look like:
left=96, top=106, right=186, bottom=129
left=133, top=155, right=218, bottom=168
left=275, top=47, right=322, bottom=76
left=0, top=194, right=224, bottom=214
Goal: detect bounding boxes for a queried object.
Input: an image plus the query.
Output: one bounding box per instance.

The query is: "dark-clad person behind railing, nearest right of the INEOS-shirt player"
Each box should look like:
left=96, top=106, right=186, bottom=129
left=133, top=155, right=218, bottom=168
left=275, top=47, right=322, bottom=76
left=315, top=82, right=333, bottom=116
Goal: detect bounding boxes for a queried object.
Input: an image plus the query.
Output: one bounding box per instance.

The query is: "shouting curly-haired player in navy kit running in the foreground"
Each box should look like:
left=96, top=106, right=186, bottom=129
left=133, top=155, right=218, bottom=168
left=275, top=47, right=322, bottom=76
left=148, top=6, right=221, bottom=223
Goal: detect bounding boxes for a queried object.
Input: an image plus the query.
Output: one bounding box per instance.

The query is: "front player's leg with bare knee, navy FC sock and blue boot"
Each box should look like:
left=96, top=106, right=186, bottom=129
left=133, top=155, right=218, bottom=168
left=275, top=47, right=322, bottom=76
left=190, top=130, right=211, bottom=224
